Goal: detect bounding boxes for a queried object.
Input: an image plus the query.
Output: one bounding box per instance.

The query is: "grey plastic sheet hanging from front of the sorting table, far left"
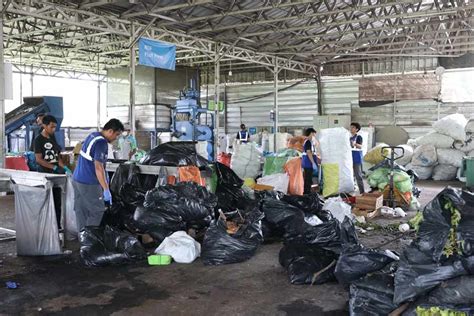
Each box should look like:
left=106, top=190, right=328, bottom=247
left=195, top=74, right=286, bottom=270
left=13, top=183, right=62, bottom=256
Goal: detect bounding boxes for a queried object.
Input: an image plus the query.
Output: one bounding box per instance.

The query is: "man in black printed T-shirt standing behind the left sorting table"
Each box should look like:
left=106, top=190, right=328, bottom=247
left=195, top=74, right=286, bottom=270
left=34, top=115, right=72, bottom=228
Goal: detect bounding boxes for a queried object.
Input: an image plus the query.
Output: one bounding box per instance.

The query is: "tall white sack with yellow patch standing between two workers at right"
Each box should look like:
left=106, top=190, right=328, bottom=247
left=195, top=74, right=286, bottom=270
left=318, top=127, right=354, bottom=197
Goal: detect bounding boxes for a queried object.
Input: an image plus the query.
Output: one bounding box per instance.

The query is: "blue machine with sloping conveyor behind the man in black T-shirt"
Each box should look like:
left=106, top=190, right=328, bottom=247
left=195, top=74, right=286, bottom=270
left=5, top=97, right=64, bottom=151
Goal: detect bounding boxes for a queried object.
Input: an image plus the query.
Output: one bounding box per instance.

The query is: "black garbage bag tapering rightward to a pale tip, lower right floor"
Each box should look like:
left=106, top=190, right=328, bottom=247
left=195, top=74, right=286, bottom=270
left=334, top=245, right=398, bottom=284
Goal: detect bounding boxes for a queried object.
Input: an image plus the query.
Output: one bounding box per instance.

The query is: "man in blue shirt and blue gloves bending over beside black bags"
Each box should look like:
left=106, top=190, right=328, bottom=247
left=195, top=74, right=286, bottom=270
left=73, top=119, right=124, bottom=231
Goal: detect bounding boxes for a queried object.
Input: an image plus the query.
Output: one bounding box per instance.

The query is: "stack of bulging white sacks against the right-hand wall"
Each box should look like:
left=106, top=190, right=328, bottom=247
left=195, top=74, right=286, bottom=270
left=405, top=114, right=466, bottom=180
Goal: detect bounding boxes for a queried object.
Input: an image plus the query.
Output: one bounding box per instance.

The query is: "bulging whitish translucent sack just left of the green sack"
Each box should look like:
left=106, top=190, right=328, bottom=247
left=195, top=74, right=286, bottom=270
left=230, top=143, right=261, bottom=179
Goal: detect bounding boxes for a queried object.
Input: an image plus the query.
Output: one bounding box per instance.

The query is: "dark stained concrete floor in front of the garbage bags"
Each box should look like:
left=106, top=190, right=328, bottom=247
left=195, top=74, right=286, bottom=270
left=0, top=181, right=460, bottom=315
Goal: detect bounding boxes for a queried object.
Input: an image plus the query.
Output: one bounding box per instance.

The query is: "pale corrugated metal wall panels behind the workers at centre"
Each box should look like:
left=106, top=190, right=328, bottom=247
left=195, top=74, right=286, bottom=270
left=206, top=79, right=359, bottom=133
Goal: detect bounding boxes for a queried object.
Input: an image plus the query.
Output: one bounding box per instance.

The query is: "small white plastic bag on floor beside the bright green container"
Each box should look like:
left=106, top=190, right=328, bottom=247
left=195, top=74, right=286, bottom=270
left=155, top=231, right=201, bottom=263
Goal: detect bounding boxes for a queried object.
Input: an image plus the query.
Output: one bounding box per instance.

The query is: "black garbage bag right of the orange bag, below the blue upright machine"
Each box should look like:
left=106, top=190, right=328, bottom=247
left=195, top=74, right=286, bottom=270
left=214, top=162, right=248, bottom=218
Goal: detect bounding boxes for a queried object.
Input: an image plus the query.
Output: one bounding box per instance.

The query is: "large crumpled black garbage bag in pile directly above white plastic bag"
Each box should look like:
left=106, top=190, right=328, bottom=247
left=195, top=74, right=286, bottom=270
left=143, top=182, right=217, bottom=228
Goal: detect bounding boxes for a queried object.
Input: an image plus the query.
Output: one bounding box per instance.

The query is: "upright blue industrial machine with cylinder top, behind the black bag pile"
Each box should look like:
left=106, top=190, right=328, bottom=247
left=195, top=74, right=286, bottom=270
left=171, top=79, right=214, bottom=161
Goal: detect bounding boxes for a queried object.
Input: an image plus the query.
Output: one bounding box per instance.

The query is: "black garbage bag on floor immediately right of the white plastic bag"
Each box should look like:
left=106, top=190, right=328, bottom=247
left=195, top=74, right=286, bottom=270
left=201, top=209, right=264, bottom=265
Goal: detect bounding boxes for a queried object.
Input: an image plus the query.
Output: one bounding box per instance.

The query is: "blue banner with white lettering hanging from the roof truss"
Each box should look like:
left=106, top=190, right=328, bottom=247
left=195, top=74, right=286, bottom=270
left=138, top=38, right=176, bottom=70
